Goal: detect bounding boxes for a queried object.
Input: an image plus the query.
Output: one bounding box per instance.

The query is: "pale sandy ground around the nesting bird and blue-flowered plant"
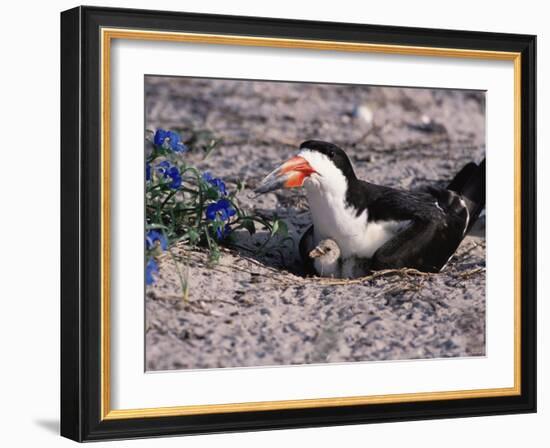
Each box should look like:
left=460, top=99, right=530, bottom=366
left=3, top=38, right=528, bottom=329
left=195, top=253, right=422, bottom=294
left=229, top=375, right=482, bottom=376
left=145, top=77, right=485, bottom=370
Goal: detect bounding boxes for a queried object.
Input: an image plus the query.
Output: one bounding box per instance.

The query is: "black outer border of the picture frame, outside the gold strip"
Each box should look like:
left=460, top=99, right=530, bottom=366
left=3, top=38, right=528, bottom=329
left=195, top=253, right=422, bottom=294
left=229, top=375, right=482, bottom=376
left=61, top=7, right=537, bottom=441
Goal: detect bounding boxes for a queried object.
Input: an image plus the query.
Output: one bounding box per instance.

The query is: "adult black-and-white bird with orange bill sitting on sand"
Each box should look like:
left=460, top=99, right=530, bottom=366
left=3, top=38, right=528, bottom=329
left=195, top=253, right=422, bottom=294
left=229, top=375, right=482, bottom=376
left=256, top=140, right=485, bottom=274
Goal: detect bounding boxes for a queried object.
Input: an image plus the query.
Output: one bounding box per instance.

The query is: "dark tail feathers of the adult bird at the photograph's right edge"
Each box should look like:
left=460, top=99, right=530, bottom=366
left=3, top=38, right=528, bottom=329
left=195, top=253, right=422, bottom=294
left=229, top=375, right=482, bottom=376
left=447, top=159, right=485, bottom=230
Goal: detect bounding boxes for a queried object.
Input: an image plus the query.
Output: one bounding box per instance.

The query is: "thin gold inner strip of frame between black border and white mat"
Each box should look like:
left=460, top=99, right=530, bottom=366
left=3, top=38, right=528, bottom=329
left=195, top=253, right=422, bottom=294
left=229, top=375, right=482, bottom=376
left=100, top=28, right=521, bottom=420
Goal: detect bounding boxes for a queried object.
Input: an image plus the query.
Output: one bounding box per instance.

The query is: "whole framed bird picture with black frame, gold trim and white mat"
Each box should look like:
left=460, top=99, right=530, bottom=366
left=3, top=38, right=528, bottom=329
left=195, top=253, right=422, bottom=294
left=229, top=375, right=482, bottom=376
left=61, top=7, right=536, bottom=441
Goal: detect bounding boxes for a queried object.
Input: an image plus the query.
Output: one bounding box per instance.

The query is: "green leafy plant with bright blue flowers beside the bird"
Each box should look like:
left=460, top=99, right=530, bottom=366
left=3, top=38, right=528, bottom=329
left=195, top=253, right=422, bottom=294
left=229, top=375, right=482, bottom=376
left=145, top=129, right=288, bottom=284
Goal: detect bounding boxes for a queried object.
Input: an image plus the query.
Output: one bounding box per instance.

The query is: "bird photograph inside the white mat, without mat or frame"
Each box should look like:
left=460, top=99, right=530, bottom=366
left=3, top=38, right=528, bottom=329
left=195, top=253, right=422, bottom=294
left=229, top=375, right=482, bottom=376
left=143, top=74, right=487, bottom=372
